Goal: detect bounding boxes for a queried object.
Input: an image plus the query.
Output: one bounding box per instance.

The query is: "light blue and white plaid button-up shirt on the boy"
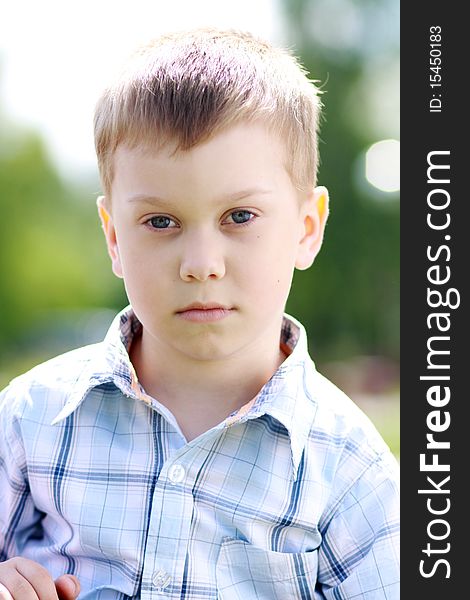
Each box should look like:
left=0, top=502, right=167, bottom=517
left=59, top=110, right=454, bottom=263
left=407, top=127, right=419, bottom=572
left=0, top=308, right=399, bottom=600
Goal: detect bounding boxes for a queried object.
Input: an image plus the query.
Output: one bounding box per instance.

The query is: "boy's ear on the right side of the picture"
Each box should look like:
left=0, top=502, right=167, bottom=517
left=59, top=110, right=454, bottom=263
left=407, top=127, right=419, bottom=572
left=295, top=186, right=329, bottom=270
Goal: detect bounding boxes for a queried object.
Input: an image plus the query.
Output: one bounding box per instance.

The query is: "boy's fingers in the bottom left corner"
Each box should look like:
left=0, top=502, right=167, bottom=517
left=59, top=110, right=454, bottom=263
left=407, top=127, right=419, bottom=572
left=0, top=557, right=80, bottom=600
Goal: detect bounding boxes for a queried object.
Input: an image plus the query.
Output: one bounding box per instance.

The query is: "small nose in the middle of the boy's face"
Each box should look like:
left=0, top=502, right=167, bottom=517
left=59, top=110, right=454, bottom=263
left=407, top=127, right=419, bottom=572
left=180, top=231, right=225, bottom=281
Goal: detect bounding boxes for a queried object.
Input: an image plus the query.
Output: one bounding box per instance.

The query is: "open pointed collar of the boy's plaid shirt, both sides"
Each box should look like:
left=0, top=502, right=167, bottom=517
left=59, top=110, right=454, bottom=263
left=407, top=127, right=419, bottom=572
left=52, top=306, right=317, bottom=479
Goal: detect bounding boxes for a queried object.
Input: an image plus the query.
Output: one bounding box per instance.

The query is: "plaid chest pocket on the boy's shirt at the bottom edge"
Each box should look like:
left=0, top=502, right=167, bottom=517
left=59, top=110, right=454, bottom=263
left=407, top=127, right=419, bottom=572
left=216, top=539, right=318, bottom=600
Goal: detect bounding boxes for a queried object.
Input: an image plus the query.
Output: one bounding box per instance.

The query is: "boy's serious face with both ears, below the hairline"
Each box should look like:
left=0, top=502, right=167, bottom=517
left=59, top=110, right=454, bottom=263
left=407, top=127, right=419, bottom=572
left=99, top=123, right=327, bottom=360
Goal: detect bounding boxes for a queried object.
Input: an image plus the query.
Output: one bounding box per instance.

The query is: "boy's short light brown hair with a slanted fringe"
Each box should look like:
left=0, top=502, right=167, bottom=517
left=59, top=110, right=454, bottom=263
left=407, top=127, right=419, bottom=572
left=94, top=28, right=321, bottom=195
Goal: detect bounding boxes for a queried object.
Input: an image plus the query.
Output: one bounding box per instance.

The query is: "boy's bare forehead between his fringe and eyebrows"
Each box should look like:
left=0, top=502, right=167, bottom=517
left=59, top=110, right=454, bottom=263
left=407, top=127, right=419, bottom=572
left=113, top=123, right=289, bottom=196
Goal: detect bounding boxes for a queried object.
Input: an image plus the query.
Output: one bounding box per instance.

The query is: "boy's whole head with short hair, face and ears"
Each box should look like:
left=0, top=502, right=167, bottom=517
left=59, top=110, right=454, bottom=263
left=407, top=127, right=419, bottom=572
left=96, top=31, right=328, bottom=360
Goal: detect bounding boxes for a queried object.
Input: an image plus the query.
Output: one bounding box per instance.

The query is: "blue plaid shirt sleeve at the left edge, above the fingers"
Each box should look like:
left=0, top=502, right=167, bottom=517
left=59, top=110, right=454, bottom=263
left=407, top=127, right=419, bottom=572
left=0, top=387, right=41, bottom=562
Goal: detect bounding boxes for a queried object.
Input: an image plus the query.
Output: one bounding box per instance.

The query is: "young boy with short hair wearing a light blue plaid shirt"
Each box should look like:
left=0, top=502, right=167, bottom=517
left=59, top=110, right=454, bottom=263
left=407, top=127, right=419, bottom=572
left=0, top=30, right=399, bottom=600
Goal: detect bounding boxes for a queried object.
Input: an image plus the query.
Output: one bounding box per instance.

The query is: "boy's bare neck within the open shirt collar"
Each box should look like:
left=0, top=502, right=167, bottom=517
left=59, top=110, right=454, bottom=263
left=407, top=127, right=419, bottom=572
left=131, top=328, right=285, bottom=439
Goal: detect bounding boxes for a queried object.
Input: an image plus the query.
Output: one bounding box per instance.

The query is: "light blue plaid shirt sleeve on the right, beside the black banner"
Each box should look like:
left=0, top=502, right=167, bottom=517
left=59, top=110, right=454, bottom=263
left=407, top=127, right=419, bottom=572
left=318, top=454, right=400, bottom=600
